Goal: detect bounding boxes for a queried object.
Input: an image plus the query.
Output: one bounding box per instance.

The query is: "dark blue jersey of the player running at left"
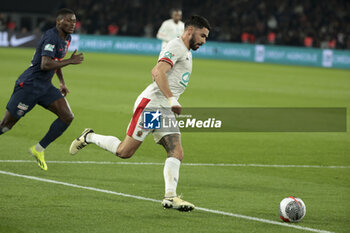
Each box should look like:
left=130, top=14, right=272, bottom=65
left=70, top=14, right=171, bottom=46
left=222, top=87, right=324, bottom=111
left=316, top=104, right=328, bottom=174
left=16, top=27, right=71, bottom=90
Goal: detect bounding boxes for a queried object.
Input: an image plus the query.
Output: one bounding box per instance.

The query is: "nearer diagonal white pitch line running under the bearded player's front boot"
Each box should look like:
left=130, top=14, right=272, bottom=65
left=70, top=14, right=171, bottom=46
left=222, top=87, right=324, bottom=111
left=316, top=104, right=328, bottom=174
left=0, top=170, right=334, bottom=233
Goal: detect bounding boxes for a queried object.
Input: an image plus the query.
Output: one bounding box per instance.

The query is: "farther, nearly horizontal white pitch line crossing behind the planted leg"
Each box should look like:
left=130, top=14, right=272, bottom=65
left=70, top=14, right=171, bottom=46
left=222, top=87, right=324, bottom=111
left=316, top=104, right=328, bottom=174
left=0, top=160, right=350, bottom=169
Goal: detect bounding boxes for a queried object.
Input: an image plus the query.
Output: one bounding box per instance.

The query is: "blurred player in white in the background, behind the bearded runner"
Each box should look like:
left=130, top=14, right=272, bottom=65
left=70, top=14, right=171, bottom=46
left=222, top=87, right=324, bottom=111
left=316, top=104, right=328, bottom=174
left=157, top=9, right=185, bottom=50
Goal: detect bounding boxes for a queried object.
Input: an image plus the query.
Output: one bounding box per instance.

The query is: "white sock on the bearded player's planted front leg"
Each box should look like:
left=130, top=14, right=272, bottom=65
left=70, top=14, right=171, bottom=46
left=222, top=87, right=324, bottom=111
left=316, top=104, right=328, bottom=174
left=163, top=157, right=181, bottom=197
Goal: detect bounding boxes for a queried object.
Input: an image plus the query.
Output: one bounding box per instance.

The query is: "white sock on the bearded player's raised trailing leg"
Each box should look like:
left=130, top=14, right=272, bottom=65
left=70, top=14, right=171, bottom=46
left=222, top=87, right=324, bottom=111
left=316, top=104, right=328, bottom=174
left=86, top=133, right=120, bottom=154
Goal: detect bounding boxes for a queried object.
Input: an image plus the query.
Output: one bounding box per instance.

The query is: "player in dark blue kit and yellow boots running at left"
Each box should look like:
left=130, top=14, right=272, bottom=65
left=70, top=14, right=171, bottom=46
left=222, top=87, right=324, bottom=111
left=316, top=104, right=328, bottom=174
left=0, top=9, right=84, bottom=170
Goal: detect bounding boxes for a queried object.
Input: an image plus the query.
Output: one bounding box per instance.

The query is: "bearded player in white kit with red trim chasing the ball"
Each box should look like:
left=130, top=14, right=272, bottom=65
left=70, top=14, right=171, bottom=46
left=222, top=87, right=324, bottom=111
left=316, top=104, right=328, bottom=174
left=70, top=16, right=210, bottom=211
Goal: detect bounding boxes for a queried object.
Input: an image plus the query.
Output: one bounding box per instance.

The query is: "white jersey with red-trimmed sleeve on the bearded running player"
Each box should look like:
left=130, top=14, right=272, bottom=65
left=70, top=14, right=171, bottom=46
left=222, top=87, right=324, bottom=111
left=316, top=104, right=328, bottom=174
left=140, top=38, right=192, bottom=106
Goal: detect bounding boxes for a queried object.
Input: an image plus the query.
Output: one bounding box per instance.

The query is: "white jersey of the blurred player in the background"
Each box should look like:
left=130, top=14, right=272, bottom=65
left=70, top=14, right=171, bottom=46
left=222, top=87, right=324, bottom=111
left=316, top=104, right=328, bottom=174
left=157, top=19, right=185, bottom=49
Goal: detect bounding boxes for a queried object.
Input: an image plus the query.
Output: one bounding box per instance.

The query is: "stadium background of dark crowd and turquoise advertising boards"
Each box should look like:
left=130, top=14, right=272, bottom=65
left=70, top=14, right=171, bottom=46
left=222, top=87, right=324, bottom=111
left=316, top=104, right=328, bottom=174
left=0, top=0, right=350, bottom=69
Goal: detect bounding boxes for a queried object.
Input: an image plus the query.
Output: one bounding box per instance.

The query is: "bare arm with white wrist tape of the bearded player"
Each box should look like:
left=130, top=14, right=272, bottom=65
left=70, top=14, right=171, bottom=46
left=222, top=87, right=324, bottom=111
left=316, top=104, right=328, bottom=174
left=152, top=61, right=182, bottom=114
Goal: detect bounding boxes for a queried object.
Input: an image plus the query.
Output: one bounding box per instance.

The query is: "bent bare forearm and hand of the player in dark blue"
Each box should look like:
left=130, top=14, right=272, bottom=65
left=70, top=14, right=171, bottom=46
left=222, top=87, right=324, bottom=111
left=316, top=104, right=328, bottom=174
left=40, top=50, right=84, bottom=70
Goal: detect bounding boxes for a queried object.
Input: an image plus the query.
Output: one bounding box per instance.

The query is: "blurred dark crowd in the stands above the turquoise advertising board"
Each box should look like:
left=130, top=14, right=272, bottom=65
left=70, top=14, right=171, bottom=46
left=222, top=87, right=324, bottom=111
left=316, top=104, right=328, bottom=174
left=0, top=0, right=350, bottom=49
